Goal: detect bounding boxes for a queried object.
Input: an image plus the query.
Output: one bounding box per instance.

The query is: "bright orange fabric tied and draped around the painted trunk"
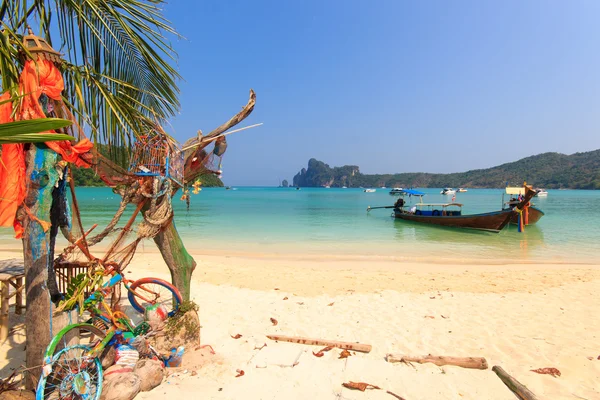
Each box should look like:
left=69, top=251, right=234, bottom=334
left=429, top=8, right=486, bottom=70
left=0, top=60, right=93, bottom=238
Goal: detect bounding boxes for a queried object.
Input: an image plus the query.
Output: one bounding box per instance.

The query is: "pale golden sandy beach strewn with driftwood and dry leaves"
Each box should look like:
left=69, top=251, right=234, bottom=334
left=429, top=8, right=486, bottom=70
left=0, top=250, right=600, bottom=400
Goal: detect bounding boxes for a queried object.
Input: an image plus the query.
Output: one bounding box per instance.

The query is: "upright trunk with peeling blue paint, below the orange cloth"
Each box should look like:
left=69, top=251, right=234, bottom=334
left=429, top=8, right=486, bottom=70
left=19, top=144, right=58, bottom=389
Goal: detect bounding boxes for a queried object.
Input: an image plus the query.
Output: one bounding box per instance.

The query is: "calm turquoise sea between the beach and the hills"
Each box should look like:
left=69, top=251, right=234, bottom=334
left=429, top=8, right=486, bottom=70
left=0, top=187, right=600, bottom=263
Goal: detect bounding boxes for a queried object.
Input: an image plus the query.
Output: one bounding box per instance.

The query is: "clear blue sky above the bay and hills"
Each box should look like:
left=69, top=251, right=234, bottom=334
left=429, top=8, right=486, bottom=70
left=164, top=0, right=600, bottom=186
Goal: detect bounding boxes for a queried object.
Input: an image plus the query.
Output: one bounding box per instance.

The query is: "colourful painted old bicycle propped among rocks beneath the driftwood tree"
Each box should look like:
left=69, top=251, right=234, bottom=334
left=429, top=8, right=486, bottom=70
left=36, top=273, right=181, bottom=400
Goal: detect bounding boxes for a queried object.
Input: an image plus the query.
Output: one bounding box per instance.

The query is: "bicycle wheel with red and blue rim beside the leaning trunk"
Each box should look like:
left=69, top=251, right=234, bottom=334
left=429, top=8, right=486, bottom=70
left=127, top=278, right=183, bottom=317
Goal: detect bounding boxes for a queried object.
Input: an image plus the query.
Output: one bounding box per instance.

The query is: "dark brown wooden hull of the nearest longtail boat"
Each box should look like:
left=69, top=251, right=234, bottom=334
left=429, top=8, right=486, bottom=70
left=394, top=209, right=514, bottom=232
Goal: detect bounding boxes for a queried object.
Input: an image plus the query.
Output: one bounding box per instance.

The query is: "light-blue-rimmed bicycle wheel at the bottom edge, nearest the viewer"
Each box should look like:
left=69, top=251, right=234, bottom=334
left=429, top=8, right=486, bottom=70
left=35, top=344, right=102, bottom=400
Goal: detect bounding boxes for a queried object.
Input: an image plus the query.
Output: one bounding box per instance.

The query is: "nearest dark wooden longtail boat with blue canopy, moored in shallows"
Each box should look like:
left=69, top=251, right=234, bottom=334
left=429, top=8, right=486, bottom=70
left=367, top=187, right=536, bottom=233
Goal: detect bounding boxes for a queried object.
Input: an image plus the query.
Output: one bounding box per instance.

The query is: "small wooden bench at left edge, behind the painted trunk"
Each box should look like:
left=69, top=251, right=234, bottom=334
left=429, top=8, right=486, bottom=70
left=0, top=258, right=25, bottom=342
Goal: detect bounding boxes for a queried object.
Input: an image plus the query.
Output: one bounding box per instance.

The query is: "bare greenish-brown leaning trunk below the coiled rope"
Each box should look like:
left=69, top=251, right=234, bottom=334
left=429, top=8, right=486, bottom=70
left=154, top=219, right=196, bottom=301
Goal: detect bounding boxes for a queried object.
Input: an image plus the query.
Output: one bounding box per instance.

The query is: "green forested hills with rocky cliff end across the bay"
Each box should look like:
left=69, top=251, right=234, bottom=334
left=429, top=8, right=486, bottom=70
left=293, top=149, right=600, bottom=189
